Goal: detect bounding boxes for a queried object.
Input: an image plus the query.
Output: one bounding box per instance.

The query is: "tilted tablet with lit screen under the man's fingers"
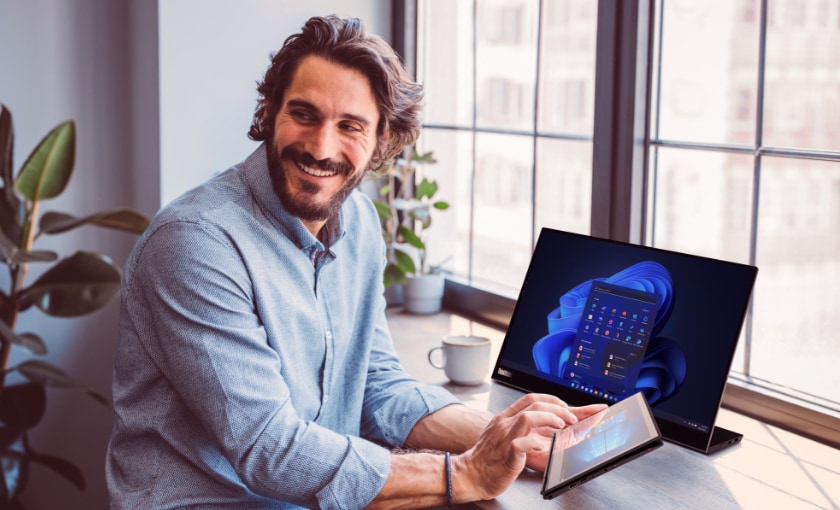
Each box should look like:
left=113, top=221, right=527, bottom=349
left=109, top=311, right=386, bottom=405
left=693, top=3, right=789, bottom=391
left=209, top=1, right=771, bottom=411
left=542, top=392, right=662, bottom=499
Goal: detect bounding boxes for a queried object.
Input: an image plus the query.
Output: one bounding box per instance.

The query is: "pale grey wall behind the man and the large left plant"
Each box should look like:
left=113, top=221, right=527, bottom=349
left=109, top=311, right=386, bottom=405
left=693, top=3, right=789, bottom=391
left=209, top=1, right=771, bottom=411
left=0, top=0, right=390, bottom=509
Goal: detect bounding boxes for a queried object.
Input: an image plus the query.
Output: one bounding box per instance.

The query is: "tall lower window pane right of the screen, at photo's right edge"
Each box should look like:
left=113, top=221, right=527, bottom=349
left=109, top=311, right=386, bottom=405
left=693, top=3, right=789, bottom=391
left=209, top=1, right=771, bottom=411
left=750, top=157, right=840, bottom=409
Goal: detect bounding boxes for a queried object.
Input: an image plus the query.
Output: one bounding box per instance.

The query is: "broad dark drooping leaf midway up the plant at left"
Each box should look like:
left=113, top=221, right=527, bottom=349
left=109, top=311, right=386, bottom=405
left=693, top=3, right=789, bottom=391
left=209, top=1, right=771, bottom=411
left=18, top=251, right=120, bottom=317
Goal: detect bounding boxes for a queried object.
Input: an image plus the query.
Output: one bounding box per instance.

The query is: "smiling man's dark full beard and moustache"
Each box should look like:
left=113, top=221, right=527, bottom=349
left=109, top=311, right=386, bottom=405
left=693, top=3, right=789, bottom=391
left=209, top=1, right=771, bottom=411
left=267, top=143, right=367, bottom=221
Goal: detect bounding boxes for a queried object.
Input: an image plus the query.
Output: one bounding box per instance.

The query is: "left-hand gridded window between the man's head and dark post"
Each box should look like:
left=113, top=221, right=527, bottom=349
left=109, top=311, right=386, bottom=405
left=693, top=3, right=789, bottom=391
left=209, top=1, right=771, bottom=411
left=417, top=0, right=597, bottom=297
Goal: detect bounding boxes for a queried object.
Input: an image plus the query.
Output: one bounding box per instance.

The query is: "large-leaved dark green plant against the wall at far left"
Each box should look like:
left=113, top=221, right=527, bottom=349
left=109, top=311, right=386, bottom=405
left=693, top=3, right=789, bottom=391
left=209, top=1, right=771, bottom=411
left=0, top=104, right=149, bottom=508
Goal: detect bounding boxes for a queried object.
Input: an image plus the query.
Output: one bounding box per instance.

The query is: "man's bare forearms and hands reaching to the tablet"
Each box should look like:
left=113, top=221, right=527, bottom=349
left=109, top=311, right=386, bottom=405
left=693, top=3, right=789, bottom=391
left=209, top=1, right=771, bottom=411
left=369, top=394, right=604, bottom=508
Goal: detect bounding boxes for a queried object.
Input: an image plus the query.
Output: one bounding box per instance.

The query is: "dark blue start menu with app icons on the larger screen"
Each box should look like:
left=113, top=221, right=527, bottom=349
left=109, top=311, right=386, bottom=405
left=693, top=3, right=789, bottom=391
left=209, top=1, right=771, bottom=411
left=563, top=282, right=659, bottom=401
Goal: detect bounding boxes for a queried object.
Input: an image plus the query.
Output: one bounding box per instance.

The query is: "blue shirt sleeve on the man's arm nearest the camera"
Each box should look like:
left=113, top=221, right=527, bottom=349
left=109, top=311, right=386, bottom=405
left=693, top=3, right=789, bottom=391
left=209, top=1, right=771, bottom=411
left=123, top=221, right=390, bottom=508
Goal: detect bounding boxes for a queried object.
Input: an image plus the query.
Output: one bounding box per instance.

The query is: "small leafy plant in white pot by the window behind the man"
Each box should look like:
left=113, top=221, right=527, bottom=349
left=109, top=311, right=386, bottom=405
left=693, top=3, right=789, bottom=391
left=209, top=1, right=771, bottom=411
left=374, top=151, right=449, bottom=313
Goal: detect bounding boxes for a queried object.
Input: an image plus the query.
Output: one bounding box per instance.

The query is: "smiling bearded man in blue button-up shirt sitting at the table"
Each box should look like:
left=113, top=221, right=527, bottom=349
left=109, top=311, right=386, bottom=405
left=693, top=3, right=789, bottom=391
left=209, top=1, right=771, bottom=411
left=106, top=13, right=599, bottom=509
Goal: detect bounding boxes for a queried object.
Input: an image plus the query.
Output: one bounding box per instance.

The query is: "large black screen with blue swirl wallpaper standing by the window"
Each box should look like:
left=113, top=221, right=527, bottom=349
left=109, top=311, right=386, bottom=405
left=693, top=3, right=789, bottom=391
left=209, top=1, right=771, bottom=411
left=492, top=228, right=758, bottom=454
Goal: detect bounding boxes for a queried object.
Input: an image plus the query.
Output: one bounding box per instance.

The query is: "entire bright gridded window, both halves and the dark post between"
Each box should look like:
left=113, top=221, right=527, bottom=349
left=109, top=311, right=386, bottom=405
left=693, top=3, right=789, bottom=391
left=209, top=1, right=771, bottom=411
left=410, top=0, right=840, bottom=440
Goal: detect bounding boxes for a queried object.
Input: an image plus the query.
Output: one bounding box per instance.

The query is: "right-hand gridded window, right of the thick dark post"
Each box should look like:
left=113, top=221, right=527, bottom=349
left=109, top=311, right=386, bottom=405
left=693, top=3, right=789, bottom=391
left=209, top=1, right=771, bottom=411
left=647, top=0, right=840, bottom=418
